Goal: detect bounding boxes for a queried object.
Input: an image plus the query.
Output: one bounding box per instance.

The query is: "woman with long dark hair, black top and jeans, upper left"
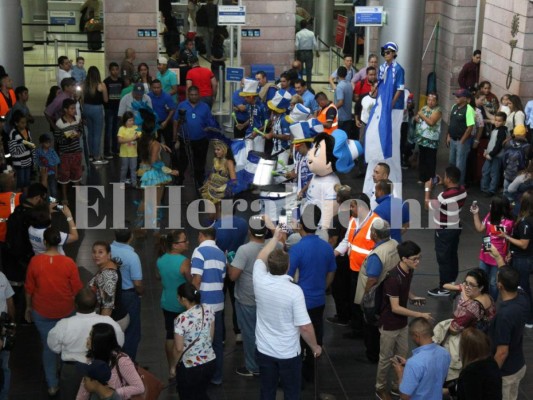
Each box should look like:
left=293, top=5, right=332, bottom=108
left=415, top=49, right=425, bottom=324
left=83, top=66, right=108, bottom=165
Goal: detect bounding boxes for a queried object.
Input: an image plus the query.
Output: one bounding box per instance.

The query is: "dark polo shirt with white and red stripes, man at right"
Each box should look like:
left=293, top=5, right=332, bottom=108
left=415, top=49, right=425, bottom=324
left=429, top=186, right=466, bottom=229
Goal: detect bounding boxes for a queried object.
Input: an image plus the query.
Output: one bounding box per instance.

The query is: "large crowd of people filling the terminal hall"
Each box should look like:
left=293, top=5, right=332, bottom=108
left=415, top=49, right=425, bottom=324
left=0, top=15, right=533, bottom=400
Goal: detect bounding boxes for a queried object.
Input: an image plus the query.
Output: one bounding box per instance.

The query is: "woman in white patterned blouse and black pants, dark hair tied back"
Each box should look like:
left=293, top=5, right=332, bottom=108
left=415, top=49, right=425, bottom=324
left=174, top=283, right=216, bottom=400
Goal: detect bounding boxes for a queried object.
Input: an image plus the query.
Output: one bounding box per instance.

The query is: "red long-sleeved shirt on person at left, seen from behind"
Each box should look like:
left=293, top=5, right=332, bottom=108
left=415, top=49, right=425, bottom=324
left=25, top=254, right=83, bottom=319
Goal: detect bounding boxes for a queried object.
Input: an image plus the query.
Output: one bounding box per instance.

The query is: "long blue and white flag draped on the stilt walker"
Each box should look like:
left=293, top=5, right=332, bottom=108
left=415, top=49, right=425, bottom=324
left=364, top=66, right=394, bottom=163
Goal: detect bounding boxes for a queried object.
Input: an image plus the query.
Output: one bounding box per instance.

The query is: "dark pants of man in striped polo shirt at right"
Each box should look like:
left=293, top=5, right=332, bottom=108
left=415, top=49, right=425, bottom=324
left=435, top=229, right=462, bottom=287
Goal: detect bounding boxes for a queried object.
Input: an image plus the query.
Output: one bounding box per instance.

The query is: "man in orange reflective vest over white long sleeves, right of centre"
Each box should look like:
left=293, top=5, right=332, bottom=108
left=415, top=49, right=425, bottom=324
left=335, top=193, right=380, bottom=338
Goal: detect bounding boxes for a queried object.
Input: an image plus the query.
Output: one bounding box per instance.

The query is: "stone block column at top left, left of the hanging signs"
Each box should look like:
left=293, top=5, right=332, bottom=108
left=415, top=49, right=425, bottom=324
left=104, top=0, right=158, bottom=73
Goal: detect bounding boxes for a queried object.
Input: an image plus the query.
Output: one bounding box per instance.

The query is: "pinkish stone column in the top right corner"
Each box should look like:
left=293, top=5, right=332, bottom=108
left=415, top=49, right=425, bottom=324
left=481, top=0, right=533, bottom=100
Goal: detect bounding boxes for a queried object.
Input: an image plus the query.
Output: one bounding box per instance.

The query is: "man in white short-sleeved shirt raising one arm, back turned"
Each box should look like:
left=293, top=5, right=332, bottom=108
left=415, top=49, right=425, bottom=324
left=253, top=227, right=322, bottom=400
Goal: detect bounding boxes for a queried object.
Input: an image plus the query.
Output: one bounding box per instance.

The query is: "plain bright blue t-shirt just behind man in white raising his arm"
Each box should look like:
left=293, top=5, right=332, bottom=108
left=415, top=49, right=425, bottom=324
left=288, top=235, right=337, bottom=310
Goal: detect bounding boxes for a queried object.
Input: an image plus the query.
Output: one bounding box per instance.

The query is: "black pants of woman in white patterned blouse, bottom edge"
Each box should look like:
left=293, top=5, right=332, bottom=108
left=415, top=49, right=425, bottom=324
left=176, top=360, right=216, bottom=400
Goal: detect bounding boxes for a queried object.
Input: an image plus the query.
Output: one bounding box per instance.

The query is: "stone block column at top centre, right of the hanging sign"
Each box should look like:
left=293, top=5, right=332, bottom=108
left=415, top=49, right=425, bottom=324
left=241, top=0, right=296, bottom=76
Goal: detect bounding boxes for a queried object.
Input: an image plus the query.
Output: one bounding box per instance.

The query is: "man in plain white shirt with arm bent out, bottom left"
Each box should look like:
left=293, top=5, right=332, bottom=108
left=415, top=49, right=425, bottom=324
left=47, top=288, right=124, bottom=399
